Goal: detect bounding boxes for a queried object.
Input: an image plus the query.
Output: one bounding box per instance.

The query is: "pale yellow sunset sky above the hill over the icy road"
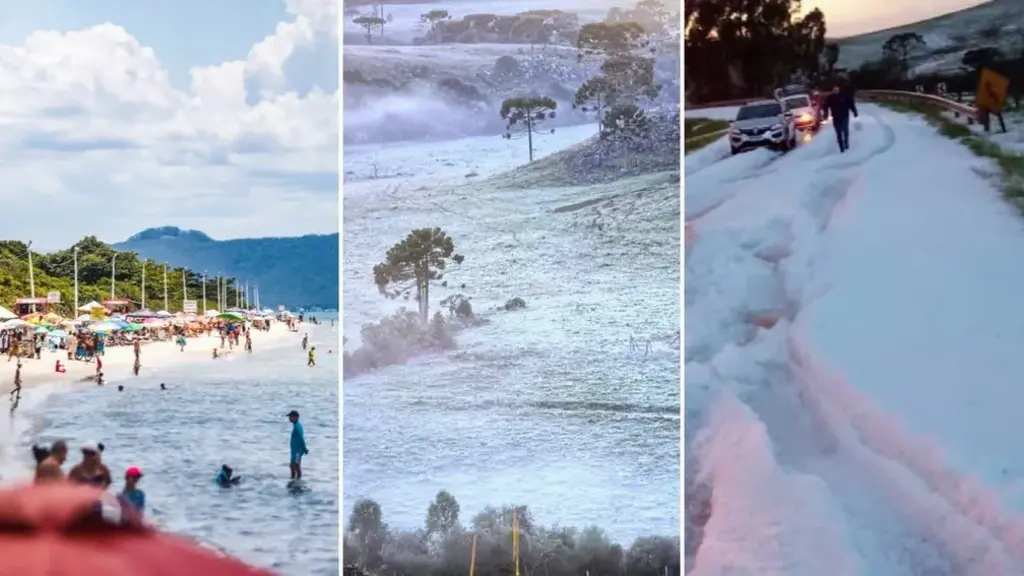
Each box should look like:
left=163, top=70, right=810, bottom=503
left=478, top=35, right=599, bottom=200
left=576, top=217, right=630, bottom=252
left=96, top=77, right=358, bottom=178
left=804, top=0, right=986, bottom=38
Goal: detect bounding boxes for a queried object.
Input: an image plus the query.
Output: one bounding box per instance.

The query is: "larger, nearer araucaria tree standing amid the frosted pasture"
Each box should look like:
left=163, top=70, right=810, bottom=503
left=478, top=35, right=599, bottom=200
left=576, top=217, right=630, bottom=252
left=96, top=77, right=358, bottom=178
left=374, top=228, right=464, bottom=323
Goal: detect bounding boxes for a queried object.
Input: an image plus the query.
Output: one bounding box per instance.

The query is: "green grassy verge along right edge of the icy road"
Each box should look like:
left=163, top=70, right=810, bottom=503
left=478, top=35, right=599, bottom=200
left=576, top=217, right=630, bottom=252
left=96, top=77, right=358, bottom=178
left=877, top=101, right=1024, bottom=208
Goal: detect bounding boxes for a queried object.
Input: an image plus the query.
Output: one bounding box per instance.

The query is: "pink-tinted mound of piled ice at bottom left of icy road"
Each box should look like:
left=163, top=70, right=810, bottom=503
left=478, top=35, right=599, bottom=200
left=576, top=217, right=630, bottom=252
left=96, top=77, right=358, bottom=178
left=690, top=385, right=859, bottom=576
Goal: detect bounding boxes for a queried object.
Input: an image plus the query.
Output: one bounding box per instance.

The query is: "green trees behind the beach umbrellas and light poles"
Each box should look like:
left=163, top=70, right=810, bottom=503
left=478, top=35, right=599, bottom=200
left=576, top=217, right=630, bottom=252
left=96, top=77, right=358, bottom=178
left=0, top=236, right=236, bottom=317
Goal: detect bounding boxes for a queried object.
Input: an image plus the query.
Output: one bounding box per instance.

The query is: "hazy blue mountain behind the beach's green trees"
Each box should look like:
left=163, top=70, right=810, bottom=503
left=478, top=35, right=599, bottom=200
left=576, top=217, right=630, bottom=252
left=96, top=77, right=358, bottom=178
left=112, top=227, right=339, bottom=310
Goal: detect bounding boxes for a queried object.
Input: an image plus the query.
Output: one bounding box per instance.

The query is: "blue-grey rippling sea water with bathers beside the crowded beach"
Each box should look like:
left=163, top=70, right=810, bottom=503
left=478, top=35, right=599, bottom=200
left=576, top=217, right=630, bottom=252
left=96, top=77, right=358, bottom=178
left=4, top=319, right=339, bottom=576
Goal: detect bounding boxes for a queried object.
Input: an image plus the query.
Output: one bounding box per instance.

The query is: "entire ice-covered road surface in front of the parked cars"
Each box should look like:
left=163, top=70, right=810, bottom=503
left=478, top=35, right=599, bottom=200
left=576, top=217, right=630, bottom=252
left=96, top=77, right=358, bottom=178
left=685, top=105, right=1024, bottom=576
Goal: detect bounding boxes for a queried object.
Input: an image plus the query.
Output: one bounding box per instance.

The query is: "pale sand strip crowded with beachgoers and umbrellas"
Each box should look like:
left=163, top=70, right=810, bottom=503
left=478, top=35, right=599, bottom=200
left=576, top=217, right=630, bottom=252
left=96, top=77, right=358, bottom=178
left=0, top=324, right=303, bottom=398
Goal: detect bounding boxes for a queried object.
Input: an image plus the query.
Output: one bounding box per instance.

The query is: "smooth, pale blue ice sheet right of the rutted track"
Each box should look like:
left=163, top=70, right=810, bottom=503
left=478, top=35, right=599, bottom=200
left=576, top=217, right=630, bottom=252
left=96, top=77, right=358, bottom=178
left=796, top=107, right=1024, bottom=562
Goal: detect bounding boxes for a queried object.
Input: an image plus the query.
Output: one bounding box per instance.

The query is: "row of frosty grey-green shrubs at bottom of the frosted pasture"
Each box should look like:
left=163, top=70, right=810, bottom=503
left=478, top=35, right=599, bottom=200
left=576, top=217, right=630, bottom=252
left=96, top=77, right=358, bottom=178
left=342, top=490, right=682, bottom=576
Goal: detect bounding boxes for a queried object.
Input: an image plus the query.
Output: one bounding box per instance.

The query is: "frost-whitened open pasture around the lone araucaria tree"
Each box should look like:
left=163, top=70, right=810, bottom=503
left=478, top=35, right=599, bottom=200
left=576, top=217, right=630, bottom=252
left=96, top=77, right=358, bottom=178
left=342, top=129, right=680, bottom=544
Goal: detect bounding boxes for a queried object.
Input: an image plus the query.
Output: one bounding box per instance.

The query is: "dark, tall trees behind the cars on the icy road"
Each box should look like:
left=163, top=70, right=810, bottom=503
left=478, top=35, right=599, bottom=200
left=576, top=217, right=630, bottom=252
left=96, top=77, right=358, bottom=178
left=683, top=0, right=826, bottom=101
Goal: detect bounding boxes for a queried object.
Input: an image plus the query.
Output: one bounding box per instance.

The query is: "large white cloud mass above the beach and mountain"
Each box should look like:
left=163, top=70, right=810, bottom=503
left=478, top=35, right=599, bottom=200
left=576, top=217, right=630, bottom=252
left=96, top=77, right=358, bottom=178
left=0, top=0, right=340, bottom=248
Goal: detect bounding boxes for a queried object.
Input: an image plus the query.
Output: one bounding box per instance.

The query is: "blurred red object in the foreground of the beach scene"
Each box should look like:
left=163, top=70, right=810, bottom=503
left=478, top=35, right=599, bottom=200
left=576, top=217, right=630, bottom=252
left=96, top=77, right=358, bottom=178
left=0, top=483, right=274, bottom=576
